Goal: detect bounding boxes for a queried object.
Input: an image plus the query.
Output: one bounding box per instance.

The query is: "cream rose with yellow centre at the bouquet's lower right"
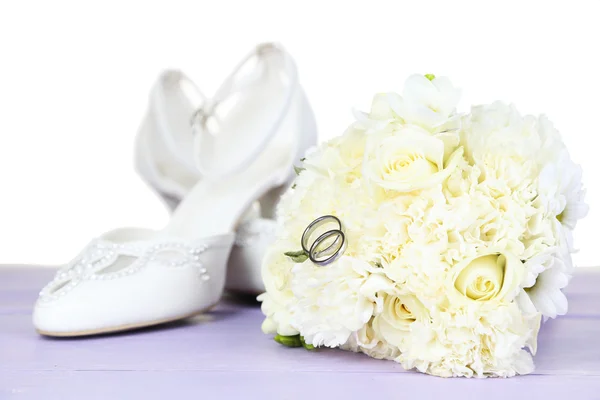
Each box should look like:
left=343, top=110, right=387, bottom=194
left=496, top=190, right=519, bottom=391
left=448, top=251, right=524, bottom=305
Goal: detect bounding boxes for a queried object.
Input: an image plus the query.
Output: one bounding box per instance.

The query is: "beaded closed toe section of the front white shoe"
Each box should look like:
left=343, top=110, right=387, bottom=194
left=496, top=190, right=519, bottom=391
left=33, top=229, right=234, bottom=336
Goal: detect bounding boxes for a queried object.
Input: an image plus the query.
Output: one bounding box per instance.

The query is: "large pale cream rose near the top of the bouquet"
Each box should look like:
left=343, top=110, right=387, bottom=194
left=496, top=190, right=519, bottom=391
left=363, top=126, right=462, bottom=192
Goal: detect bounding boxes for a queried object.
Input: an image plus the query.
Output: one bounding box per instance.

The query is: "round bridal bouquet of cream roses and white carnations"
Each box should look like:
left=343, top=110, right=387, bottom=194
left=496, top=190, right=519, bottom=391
left=259, top=75, right=587, bottom=377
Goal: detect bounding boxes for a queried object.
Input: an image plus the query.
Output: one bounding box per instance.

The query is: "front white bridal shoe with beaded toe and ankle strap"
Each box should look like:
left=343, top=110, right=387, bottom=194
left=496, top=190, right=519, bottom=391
left=33, top=44, right=314, bottom=336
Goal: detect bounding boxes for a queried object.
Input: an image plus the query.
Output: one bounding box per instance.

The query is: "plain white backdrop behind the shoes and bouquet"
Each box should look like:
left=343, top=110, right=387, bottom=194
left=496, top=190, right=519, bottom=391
left=0, top=0, right=600, bottom=265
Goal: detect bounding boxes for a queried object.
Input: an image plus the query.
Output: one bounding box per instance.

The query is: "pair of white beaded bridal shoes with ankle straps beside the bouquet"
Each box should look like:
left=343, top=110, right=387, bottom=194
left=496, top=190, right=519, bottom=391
left=33, top=45, right=315, bottom=336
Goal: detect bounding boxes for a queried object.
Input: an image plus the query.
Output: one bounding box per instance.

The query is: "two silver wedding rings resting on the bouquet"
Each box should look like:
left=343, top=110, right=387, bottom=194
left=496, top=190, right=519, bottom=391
left=301, top=215, right=346, bottom=266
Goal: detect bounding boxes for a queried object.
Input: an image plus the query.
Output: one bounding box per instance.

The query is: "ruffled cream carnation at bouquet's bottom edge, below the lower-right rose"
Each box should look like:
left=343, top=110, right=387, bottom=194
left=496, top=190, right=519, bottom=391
left=397, top=304, right=539, bottom=377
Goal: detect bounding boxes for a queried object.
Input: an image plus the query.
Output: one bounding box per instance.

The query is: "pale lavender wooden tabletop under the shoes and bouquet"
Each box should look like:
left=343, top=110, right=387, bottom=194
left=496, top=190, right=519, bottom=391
left=0, top=267, right=600, bottom=400
